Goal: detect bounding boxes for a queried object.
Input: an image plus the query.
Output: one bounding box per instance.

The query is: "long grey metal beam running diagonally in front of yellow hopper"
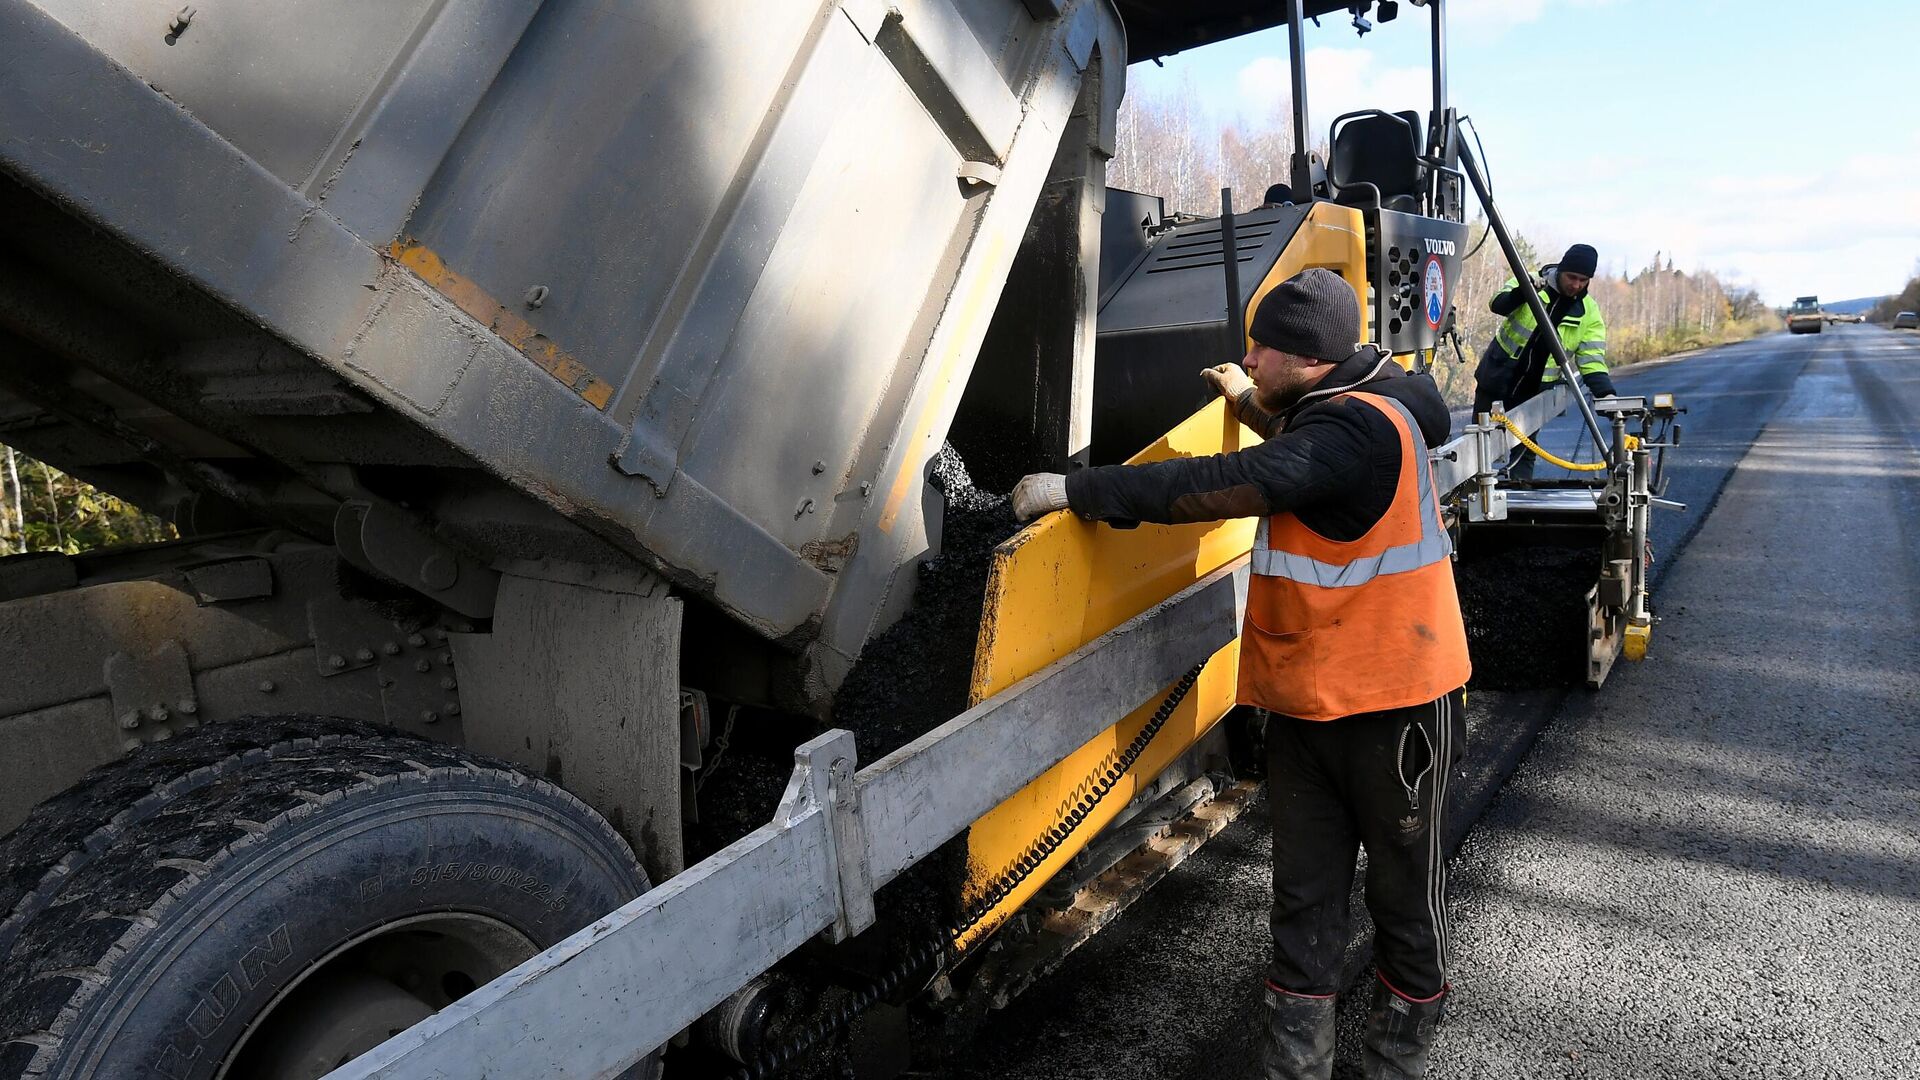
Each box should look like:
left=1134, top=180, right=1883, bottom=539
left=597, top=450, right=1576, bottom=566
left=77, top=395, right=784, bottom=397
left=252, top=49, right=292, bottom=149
left=328, top=559, right=1246, bottom=1080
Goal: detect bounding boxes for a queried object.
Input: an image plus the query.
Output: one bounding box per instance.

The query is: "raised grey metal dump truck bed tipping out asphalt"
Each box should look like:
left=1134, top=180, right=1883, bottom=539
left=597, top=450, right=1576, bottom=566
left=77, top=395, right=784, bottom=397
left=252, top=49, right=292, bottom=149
left=0, top=0, right=1125, bottom=707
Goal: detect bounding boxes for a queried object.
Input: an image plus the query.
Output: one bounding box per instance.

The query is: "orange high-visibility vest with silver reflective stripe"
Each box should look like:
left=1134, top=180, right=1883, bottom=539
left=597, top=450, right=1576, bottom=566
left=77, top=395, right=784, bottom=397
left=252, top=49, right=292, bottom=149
left=1238, top=394, right=1473, bottom=721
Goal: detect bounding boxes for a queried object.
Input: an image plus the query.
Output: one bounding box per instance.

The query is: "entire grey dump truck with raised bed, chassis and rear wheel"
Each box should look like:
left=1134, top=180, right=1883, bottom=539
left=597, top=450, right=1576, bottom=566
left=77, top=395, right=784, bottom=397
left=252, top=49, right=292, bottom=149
left=0, top=10, right=1136, bottom=1076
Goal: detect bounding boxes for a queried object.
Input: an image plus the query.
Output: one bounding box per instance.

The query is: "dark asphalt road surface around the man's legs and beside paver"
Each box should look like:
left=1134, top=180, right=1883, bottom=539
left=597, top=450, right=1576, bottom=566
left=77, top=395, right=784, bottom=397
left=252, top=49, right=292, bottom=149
left=947, top=327, right=1920, bottom=1080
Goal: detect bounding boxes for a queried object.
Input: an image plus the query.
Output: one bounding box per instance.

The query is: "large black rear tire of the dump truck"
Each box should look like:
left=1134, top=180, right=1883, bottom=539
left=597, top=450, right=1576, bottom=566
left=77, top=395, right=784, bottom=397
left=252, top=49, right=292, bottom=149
left=0, top=717, right=659, bottom=1080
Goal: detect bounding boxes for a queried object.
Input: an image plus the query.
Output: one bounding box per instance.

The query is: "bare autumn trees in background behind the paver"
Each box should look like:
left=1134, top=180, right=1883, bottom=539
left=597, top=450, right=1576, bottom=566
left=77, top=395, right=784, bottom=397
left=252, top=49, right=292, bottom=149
left=1108, top=85, right=1780, bottom=404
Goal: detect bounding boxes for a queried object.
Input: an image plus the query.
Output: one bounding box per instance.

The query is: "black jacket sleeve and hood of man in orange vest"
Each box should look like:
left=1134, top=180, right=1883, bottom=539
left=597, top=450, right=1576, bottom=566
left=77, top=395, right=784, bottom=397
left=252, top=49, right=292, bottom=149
left=1068, top=348, right=1450, bottom=540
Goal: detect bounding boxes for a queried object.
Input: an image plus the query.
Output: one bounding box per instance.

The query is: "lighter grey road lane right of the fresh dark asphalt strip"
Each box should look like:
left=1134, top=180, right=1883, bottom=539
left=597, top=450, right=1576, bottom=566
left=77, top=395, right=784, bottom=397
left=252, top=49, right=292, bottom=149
left=1434, top=322, right=1920, bottom=1078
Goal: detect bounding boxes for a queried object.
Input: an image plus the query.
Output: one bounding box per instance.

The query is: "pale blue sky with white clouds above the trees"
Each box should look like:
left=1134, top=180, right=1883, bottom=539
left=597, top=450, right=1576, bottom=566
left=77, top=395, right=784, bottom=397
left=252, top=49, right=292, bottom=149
left=1127, top=0, right=1920, bottom=302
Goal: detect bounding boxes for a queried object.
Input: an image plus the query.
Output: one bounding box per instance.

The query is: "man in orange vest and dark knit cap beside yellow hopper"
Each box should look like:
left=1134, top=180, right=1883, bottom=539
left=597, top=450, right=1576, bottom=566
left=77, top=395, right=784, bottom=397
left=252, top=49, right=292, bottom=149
left=1014, top=269, right=1469, bottom=1080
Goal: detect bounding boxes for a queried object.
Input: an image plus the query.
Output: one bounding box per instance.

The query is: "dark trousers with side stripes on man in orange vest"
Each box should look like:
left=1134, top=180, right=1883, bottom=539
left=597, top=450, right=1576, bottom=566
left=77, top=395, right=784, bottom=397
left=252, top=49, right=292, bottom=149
left=1267, top=690, right=1467, bottom=997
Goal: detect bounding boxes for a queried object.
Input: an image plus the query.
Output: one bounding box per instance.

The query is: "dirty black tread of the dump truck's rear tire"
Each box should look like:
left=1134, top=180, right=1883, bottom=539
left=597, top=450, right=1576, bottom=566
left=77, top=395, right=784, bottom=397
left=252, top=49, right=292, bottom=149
left=0, top=715, right=632, bottom=1078
